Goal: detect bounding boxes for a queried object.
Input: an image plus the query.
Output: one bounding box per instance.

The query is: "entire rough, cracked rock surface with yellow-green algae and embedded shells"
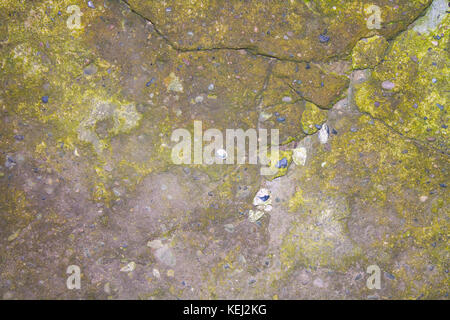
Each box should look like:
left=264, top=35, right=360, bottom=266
left=0, top=0, right=450, bottom=299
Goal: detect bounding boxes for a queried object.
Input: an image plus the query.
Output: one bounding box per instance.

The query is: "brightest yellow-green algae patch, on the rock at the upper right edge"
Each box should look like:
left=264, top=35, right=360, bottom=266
left=355, top=15, right=450, bottom=152
